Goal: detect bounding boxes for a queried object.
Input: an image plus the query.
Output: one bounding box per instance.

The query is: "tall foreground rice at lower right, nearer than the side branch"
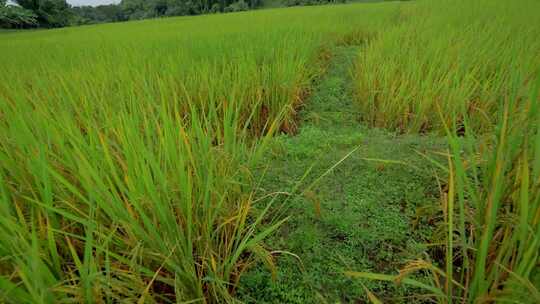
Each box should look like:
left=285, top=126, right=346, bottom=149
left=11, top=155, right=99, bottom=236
left=347, top=69, right=540, bottom=303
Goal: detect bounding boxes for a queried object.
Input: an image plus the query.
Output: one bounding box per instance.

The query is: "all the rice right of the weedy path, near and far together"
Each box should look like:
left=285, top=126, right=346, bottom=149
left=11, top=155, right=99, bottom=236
left=348, top=1, right=540, bottom=303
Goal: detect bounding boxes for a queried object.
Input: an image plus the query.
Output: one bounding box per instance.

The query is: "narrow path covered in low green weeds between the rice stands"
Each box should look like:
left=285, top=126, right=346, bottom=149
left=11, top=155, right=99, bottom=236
left=239, top=46, right=443, bottom=303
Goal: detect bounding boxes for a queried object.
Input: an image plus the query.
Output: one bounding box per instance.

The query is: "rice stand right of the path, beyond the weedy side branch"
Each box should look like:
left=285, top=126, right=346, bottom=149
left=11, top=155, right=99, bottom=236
left=356, top=0, right=540, bottom=133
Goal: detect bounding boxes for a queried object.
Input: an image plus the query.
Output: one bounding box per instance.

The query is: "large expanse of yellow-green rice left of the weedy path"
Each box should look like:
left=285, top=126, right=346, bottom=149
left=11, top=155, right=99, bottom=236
left=0, top=6, right=396, bottom=303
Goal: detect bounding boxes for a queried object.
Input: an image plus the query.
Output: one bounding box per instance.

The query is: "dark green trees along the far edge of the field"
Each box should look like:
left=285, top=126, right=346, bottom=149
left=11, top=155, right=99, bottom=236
left=0, top=0, right=345, bottom=29
